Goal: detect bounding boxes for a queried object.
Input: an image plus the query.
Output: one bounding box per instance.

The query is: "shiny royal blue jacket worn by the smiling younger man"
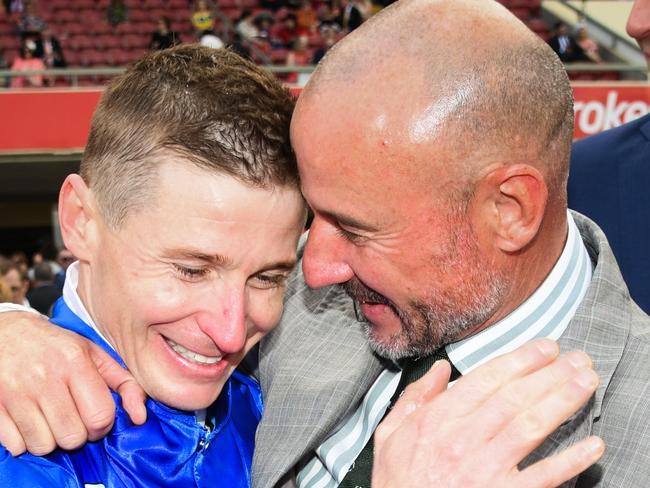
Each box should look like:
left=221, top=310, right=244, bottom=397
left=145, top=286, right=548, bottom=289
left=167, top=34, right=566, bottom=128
left=0, top=299, right=262, bottom=488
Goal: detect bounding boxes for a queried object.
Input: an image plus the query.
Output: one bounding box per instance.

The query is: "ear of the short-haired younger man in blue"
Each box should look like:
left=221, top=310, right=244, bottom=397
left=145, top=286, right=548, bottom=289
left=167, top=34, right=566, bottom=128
left=59, top=174, right=97, bottom=261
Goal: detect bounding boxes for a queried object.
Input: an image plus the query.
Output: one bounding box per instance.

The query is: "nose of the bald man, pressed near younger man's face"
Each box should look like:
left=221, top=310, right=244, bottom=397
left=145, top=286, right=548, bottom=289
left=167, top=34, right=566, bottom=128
left=302, top=216, right=354, bottom=288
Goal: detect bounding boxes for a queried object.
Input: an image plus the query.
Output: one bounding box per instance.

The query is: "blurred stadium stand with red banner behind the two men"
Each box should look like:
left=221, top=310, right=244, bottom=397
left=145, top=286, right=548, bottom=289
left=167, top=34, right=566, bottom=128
left=0, top=0, right=650, bottom=255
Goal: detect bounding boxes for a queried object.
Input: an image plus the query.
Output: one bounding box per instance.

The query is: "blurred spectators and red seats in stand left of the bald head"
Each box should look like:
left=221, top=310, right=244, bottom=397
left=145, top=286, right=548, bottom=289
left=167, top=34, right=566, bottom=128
left=0, top=0, right=384, bottom=88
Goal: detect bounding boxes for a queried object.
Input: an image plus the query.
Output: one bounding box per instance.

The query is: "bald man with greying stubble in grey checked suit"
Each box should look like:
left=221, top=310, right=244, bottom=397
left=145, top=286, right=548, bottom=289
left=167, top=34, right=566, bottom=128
left=0, top=0, right=650, bottom=487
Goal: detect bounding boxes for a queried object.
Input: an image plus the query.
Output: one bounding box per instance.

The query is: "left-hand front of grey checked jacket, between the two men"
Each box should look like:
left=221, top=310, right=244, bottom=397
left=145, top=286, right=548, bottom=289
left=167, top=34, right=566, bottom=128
left=253, top=273, right=383, bottom=488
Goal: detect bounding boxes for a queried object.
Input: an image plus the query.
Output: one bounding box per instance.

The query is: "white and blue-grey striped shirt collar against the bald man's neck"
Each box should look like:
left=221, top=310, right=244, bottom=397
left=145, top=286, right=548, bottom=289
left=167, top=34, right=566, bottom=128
left=446, top=212, right=593, bottom=374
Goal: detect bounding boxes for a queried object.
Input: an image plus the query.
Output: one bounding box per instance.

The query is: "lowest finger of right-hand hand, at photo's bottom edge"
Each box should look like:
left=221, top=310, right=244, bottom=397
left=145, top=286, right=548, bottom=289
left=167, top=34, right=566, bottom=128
left=512, top=436, right=605, bottom=488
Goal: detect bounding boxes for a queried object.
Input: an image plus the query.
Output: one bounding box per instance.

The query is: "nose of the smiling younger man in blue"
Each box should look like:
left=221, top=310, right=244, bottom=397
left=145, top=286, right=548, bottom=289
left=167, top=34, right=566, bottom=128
left=198, top=286, right=247, bottom=354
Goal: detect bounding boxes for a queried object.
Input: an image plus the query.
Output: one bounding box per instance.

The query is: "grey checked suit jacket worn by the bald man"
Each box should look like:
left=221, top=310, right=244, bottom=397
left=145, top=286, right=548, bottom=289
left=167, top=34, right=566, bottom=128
left=253, top=214, right=650, bottom=488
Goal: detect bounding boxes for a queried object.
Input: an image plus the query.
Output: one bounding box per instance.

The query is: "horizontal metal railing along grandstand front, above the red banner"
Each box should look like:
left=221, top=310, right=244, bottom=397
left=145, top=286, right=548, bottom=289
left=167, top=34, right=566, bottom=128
left=0, top=63, right=648, bottom=87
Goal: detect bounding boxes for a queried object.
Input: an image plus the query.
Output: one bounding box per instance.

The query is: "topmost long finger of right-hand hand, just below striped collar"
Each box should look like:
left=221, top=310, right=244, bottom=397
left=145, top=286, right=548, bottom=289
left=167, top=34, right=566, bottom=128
left=446, top=339, right=560, bottom=416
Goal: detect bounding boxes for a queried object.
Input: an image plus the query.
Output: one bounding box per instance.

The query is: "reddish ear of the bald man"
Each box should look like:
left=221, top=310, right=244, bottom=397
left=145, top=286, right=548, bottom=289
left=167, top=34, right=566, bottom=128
left=475, top=164, right=548, bottom=253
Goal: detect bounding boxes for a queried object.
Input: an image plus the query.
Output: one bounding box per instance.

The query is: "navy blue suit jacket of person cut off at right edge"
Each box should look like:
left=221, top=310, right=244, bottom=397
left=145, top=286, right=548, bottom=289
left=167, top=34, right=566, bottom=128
left=569, top=114, right=650, bottom=313
